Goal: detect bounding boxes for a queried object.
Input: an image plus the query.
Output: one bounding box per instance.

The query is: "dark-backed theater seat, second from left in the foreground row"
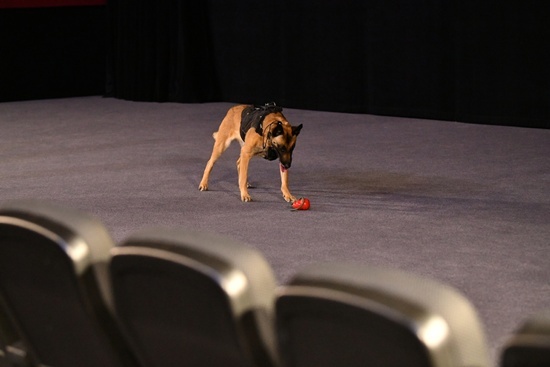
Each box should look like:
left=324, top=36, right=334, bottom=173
left=110, top=229, right=276, bottom=367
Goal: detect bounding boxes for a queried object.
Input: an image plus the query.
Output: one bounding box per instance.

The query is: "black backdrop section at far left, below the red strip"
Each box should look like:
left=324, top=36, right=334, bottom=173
left=0, top=5, right=107, bottom=102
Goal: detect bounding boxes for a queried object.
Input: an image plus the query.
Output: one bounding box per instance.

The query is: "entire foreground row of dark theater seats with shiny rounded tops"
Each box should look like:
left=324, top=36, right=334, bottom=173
left=0, top=201, right=550, bottom=367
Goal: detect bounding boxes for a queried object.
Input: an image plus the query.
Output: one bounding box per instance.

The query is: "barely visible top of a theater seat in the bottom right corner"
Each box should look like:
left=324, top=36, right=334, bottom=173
left=501, top=309, right=550, bottom=367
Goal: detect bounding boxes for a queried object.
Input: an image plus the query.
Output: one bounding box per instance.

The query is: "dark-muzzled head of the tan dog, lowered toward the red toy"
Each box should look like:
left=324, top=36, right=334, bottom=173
left=265, top=121, right=302, bottom=171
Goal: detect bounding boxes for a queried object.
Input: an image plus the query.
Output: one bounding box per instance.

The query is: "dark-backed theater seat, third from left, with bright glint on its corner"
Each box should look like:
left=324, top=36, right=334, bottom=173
left=276, top=263, right=490, bottom=367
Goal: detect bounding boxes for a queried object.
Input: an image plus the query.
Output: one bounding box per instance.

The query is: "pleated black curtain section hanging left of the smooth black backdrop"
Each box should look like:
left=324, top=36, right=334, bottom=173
left=106, top=0, right=220, bottom=102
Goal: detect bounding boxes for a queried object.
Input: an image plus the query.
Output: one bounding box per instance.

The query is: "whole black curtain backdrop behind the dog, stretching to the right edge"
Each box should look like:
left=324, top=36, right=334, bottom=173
left=107, top=0, right=550, bottom=127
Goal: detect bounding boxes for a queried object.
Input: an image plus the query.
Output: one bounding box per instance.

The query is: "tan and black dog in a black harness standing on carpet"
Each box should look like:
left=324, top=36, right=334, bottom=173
left=199, top=103, right=302, bottom=202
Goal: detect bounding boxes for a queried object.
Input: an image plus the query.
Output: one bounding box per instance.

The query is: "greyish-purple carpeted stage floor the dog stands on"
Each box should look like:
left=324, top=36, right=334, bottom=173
left=0, top=97, right=550, bottom=366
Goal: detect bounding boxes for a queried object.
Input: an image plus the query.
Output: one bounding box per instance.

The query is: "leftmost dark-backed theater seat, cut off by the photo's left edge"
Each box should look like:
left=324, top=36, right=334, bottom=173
left=0, top=201, right=140, bottom=367
